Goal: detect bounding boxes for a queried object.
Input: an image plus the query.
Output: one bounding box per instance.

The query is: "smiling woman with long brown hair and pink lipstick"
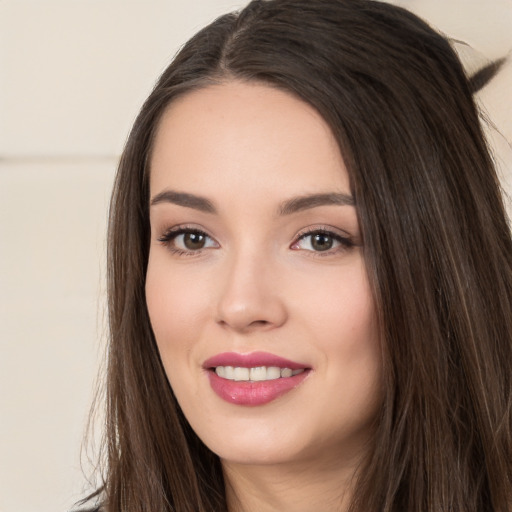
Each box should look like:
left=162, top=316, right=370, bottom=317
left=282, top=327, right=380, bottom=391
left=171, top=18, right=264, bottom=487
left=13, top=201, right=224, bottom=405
left=82, top=0, right=512, bottom=512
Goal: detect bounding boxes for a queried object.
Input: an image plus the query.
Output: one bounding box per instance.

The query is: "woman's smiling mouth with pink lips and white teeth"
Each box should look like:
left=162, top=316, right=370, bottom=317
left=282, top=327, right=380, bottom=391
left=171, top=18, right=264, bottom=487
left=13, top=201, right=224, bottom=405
left=203, top=352, right=311, bottom=406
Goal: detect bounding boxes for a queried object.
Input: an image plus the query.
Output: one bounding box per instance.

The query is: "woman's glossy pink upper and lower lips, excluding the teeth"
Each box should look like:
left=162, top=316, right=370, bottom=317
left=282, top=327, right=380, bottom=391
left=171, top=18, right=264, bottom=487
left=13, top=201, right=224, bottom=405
left=203, top=352, right=311, bottom=406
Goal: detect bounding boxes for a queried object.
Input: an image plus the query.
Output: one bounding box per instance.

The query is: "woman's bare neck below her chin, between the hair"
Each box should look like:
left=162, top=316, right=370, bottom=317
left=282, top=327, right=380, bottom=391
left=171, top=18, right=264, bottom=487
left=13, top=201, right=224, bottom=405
left=223, top=456, right=356, bottom=512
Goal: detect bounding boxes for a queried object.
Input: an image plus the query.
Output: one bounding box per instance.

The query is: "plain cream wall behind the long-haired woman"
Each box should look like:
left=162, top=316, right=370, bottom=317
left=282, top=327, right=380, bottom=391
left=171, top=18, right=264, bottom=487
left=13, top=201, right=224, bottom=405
left=0, top=0, right=512, bottom=512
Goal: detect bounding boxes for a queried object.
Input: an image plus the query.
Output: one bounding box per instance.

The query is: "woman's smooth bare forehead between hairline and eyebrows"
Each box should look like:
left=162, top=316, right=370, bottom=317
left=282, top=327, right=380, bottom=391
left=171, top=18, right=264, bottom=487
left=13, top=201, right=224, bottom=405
left=146, top=82, right=350, bottom=199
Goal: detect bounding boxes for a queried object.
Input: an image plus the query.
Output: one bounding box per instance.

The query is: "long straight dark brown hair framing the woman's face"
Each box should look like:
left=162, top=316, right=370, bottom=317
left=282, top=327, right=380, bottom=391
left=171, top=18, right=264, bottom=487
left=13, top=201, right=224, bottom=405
left=85, top=0, right=512, bottom=512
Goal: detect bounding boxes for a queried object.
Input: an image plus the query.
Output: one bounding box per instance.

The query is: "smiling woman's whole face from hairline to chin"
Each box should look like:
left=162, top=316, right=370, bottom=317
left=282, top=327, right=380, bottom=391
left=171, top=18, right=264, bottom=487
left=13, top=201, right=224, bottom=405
left=146, top=82, right=381, bottom=470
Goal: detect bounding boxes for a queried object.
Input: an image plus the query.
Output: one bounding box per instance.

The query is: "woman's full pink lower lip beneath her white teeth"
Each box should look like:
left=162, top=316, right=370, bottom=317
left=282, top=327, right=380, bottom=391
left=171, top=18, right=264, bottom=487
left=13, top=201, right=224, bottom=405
left=208, top=370, right=310, bottom=406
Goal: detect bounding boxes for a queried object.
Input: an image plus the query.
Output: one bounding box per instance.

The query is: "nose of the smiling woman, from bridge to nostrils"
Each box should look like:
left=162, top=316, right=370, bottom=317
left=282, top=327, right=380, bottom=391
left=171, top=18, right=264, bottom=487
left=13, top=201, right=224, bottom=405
left=217, top=248, right=288, bottom=333
